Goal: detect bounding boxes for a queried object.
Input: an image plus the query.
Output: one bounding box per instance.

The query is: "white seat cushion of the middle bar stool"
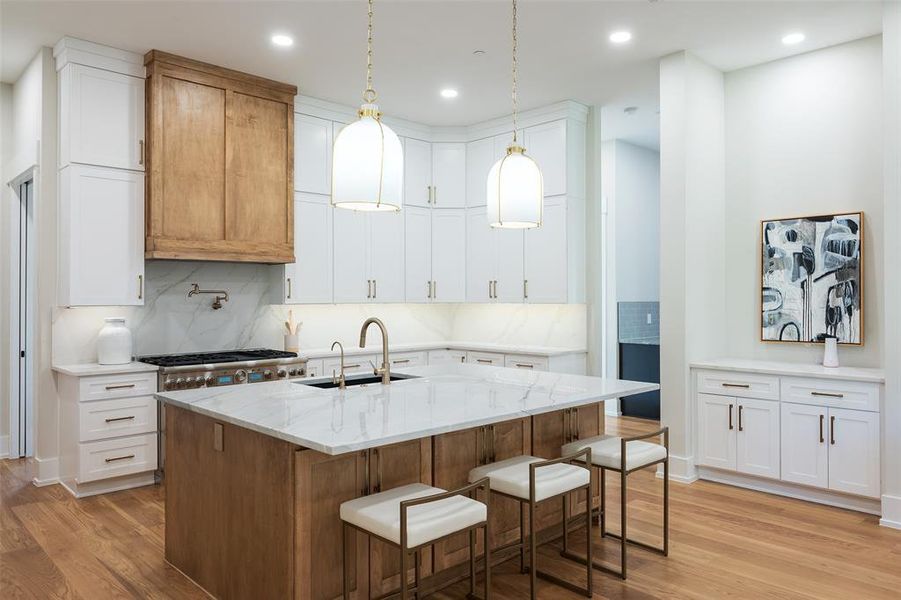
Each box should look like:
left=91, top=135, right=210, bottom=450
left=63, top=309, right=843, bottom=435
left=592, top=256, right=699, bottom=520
left=469, top=456, right=591, bottom=502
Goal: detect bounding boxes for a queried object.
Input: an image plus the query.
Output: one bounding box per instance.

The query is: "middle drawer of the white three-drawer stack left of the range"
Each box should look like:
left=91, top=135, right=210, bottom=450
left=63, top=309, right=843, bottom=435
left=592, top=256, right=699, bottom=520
left=78, top=396, right=157, bottom=442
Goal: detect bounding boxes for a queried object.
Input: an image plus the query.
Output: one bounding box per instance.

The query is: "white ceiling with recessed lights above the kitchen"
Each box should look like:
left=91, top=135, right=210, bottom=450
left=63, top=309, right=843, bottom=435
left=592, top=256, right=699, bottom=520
left=0, top=0, right=882, bottom=146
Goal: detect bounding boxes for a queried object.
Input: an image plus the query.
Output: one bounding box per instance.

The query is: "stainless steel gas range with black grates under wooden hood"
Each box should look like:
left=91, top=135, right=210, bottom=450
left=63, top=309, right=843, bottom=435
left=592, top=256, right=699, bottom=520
left=138, top=349, right=307, bottom=391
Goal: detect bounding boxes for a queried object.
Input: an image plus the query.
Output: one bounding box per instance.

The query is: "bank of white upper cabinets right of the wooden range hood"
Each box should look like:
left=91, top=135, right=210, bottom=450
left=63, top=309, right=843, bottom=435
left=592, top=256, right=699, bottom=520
left=272, top=99, right=587, bottom=304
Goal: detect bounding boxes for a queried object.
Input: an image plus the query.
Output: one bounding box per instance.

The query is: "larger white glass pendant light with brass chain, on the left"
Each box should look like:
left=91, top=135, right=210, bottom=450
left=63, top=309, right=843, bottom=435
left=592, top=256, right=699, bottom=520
left=332, top=0, right=404, bottom=211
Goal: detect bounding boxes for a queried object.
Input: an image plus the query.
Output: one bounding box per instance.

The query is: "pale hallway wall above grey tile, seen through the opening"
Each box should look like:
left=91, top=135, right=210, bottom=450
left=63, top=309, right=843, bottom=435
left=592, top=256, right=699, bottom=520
left=602, top=140, right=660, bottom=302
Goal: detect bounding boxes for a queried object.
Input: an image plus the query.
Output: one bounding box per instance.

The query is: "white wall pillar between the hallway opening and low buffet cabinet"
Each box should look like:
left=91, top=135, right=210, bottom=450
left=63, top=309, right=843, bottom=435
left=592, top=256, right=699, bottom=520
left=660, top=52, right=726, bottom=480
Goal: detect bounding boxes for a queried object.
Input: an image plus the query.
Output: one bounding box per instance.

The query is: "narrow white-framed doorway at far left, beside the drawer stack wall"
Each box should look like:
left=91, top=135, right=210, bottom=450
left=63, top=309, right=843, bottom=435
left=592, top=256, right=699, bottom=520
left=9, top=175, right=35, bottom=458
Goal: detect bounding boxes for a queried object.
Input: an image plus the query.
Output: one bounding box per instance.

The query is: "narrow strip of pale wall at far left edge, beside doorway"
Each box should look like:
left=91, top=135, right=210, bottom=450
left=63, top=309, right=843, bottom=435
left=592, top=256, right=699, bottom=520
left=0, top=83, right=13, bottom=456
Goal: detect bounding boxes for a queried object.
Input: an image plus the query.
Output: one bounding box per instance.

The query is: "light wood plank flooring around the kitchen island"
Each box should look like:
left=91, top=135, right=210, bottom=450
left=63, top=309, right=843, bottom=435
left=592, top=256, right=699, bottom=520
left=0, top=418, right=901, bottom=600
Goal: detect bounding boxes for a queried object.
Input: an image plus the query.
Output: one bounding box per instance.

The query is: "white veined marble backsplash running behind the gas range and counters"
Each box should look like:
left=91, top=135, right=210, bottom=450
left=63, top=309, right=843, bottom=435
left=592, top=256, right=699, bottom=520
left=53, top=260, right=587, bottom=364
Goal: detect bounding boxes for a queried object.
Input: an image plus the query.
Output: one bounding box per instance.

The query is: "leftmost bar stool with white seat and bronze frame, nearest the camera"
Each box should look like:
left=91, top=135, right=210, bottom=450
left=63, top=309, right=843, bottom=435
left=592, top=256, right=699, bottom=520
left=340, top=479, right=491, bottom=600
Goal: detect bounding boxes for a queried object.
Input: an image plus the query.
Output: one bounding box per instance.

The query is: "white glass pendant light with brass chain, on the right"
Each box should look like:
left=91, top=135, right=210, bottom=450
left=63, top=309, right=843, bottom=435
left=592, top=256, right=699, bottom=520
left=488, top=0, right=544, bottom=229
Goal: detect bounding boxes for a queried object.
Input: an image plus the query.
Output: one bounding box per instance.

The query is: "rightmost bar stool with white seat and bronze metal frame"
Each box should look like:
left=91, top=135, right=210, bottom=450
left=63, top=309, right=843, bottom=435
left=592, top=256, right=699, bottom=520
left=562, top=427, right=669, bottom=579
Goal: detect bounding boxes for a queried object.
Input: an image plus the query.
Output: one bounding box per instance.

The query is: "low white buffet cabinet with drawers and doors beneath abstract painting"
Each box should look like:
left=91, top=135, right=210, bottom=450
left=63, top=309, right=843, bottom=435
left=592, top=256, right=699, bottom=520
left=693, top=365, right=882, bottom=510
